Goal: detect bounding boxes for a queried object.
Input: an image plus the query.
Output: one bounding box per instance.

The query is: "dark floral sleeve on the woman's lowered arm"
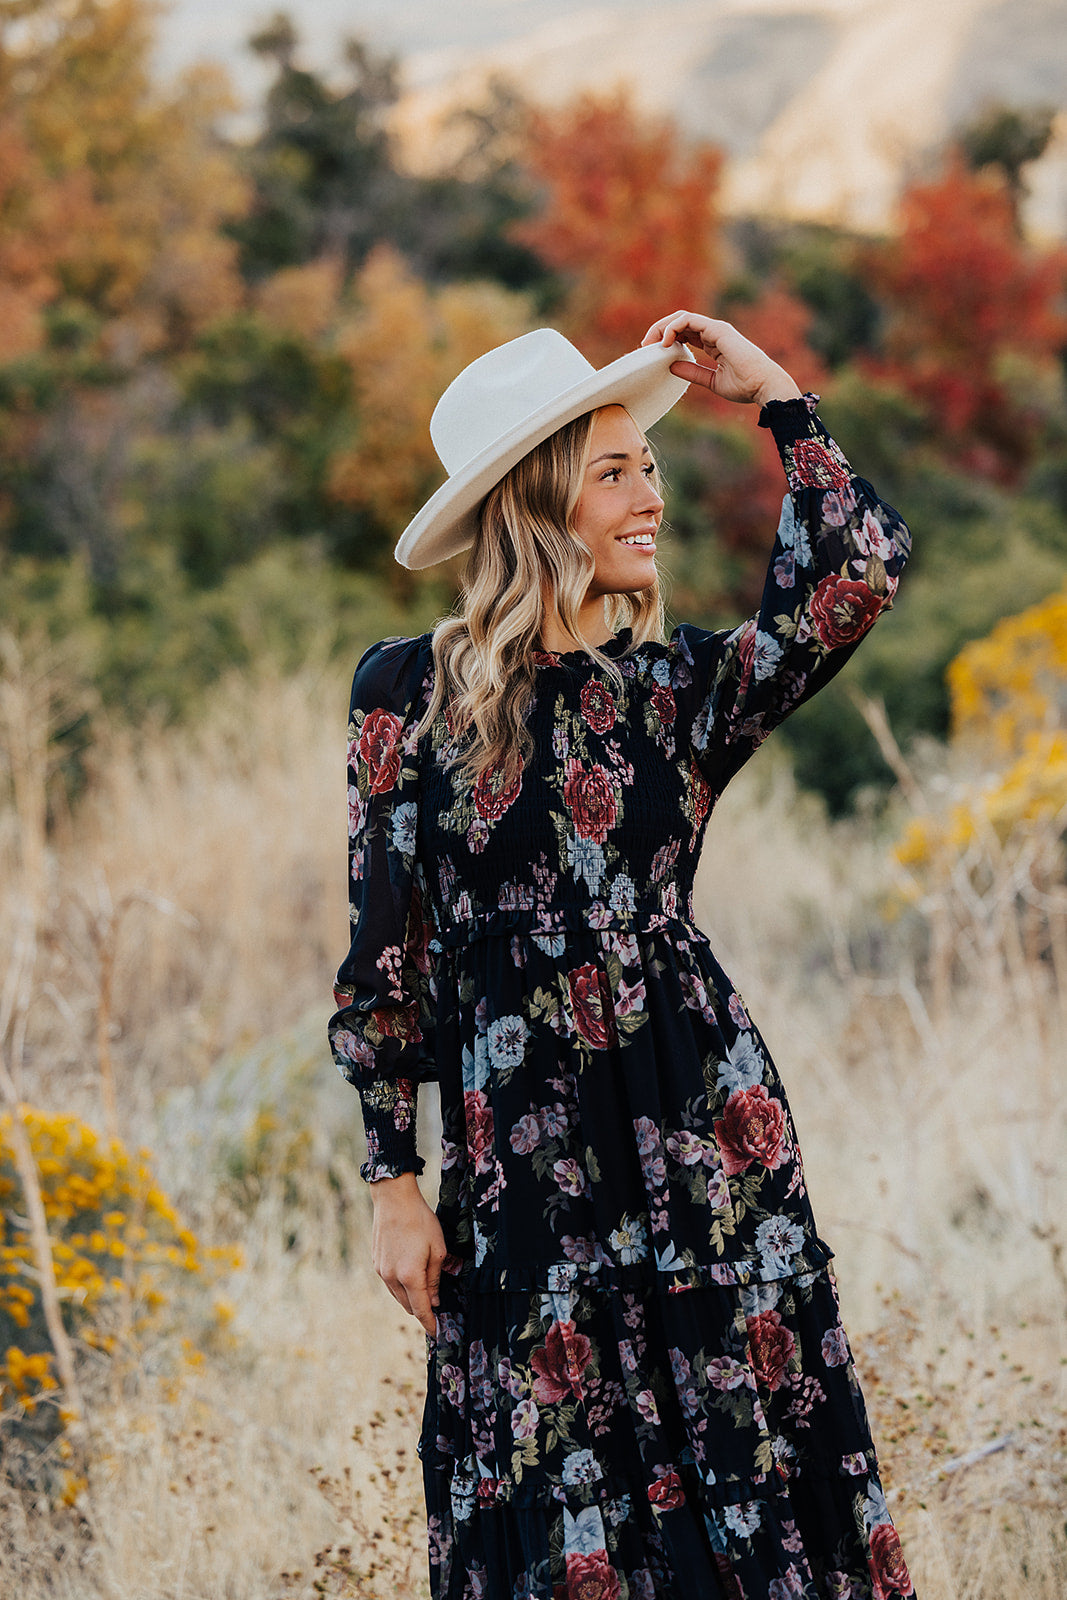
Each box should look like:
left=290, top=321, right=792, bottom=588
left=328, top=635, right=437, bottom=1182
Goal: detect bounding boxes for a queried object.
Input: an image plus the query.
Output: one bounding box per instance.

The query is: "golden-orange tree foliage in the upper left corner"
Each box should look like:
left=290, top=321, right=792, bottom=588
left=0, top=0, right=248, bottom=357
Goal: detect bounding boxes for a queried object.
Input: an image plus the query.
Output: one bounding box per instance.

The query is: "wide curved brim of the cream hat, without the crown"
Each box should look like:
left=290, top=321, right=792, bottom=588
left=394, top=342, right=691, bottom=571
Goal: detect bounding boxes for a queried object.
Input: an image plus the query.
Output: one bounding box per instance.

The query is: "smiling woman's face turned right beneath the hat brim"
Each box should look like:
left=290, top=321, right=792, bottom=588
left=574, top=405, right=664, bottom=598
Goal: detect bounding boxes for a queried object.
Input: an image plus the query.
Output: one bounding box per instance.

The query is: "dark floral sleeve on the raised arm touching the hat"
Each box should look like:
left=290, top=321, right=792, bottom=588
left=670, top=395, right=912, bottom=794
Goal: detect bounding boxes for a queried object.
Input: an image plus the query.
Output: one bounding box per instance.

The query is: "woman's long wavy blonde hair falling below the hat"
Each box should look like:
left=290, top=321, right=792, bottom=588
left=416, top=411, right=664, bottom=787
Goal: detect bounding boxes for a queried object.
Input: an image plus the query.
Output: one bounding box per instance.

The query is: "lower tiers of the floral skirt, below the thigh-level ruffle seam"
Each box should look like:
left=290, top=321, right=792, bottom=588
left=419, top=1251, right=913, bottom=1600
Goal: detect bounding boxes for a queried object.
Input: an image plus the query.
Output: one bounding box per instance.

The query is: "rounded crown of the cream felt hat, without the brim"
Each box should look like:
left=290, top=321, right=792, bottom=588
left=430, top=328, right=595, bottom=474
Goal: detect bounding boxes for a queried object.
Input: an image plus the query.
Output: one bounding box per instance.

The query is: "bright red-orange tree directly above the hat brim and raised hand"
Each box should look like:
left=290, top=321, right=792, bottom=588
left=515, top=90, right=721, bottom=365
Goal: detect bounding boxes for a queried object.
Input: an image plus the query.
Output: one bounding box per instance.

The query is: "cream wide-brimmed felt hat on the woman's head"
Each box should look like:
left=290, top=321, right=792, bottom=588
left=394, top=328, right=689, bottom=568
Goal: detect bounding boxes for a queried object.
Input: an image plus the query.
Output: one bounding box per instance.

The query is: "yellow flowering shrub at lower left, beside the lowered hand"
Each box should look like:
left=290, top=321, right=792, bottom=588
left=0, top=1106, right=238, bottom=1418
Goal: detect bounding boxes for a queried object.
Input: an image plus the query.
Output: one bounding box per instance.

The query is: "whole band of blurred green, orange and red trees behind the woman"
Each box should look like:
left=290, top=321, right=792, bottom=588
left=0, top=0, right=1067, bottom=813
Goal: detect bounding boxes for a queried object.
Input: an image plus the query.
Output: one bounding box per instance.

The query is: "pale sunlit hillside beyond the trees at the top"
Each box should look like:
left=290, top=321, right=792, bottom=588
left=390, top=0, right=1067, bottom=235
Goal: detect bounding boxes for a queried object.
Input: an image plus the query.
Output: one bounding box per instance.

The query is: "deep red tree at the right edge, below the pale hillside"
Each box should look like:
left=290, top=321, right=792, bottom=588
left=861, top=158, right=1067, bottom=480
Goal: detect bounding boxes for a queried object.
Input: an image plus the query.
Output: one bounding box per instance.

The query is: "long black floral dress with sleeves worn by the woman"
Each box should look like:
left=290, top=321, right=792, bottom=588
left=330, top=395, right=913, bottom=1600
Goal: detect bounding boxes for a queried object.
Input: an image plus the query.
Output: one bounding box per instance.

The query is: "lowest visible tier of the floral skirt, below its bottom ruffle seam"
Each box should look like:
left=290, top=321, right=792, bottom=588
left=426, top=1462, right=915, bottom=1600
